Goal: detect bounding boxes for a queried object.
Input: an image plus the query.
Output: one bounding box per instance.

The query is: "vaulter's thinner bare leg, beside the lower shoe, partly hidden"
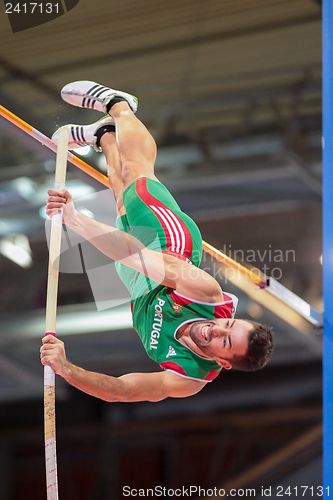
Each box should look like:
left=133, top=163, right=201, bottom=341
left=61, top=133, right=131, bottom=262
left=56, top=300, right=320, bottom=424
left=100, top=132, right=126, bottom=215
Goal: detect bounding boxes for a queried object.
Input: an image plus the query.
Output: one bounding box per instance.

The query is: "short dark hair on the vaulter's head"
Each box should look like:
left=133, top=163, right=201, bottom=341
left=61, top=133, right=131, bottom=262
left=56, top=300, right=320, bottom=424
left=230, top=321, right=274, bottom=372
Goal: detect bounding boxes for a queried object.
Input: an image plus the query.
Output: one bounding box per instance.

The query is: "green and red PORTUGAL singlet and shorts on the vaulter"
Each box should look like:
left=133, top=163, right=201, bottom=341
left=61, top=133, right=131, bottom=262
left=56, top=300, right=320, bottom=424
left=116, top=177, right=238, bottom=382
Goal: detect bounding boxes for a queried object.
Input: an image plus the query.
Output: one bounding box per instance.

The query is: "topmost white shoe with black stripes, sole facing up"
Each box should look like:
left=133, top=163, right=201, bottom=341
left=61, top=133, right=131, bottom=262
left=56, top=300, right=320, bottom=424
left=61, top=80, right=138, bottom=113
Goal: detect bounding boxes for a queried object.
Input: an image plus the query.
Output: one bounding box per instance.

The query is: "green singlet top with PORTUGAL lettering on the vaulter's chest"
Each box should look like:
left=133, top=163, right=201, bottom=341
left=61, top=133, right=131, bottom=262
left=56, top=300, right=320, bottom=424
left=132, top=286, right=238, bottom=381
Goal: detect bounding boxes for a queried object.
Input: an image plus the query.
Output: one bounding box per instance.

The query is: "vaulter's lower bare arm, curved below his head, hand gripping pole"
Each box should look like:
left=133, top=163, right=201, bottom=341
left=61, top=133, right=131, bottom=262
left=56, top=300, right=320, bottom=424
left=40, top=335, right=206, bottom=402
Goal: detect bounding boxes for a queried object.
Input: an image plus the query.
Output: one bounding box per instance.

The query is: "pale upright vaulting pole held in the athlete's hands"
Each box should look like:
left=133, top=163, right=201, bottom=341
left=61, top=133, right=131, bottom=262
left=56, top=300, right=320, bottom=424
left=44, top=128, right=68, bottom=500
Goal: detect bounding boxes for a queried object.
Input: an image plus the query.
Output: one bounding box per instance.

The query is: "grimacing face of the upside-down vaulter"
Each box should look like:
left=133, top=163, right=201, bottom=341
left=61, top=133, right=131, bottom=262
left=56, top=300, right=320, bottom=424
left=189, top=319, right=253, bottom=368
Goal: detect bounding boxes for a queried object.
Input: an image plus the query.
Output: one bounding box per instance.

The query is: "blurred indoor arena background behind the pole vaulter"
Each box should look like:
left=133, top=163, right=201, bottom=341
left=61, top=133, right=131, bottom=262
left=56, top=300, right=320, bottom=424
left=0, top=0, right=322, bottom=500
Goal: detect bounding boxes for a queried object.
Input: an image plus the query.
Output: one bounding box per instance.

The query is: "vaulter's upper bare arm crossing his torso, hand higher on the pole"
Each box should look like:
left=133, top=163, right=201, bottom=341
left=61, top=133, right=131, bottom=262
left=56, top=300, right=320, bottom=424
left=47, top=189, right=223, bottom=302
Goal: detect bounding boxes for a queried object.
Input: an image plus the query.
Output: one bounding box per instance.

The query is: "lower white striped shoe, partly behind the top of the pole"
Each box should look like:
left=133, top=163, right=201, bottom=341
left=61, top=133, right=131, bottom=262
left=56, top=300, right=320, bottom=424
left=52, top=115, right=115, bottom=152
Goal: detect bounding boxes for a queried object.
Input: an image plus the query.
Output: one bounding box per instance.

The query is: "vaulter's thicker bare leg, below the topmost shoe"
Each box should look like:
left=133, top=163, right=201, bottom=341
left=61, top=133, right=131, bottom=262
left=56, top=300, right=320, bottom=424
left=106, top=101, right=157, bottom=188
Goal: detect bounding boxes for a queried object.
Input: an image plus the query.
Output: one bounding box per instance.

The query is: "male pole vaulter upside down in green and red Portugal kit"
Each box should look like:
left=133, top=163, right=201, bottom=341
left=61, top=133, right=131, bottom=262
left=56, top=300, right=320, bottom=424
left=41, top=81, right=273, bottom=402
